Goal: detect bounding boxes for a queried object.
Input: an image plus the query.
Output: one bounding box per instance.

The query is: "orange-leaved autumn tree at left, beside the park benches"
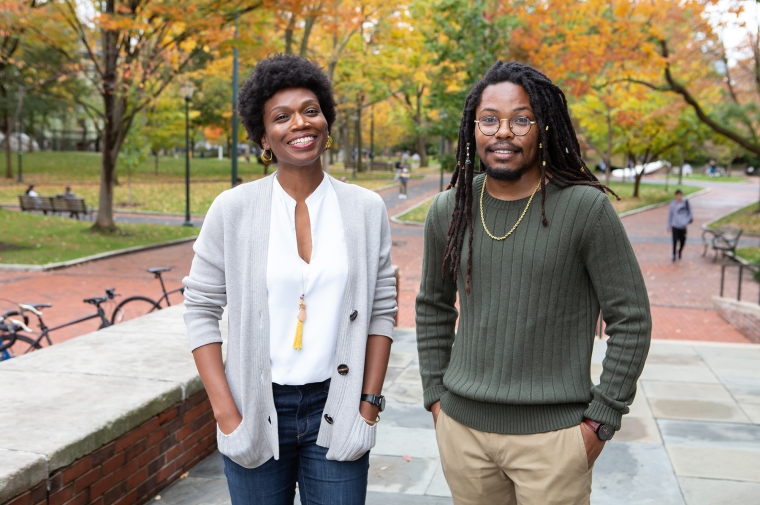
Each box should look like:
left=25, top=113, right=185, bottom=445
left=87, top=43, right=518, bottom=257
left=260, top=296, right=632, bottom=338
left=35, top=0, right=261, bottom=231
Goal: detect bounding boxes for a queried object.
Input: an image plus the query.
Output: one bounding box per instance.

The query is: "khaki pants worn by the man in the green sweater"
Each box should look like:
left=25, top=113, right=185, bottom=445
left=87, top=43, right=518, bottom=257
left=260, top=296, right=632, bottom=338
left=435, top=410, right=591, bottom=505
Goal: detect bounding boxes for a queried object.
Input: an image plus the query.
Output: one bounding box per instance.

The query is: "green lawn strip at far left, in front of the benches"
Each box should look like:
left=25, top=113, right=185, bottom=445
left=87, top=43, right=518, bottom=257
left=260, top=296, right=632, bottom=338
left=0, top=209, right=199, bottom=265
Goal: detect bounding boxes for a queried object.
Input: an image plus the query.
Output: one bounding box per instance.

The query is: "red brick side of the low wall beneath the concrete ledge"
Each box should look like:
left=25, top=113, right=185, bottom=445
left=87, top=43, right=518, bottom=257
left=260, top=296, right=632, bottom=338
left=3, top=390, right=216, bottom=505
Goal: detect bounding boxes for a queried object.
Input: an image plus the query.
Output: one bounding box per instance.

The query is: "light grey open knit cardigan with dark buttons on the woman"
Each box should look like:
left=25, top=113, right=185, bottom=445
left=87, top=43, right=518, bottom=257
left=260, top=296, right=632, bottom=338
left=183, top=174, right=397, bottom=468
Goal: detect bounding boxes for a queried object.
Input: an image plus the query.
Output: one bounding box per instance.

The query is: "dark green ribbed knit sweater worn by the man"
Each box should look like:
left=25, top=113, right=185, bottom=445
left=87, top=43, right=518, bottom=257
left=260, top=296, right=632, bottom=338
left=416, top=175, right=652, bottom=434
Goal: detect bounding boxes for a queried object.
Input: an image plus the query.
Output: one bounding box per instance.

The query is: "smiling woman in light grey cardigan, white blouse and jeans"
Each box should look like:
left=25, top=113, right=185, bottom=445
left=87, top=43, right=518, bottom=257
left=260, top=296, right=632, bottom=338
left=183, top=55, right=396, bottom=505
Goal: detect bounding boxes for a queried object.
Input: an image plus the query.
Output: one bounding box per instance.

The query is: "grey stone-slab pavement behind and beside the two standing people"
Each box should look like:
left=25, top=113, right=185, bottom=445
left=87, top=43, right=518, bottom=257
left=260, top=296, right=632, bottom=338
left=154, top=329, right=760, bottom=505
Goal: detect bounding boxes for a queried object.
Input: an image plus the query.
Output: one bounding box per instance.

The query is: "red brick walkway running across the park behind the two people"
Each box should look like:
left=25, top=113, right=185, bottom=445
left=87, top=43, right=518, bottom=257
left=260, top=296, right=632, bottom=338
left=0, top=176, right=760, bottom=342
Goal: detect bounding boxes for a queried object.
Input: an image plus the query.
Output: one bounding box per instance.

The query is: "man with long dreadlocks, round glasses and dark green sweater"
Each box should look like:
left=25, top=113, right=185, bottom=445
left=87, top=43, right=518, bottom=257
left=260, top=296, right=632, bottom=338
left=417, top=61, right=652, bottom=505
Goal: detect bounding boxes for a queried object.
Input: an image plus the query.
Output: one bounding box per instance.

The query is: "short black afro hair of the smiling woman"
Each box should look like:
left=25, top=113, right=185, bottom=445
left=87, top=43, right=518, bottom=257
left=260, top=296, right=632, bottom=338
left=238, top=54, right=335, bottom=150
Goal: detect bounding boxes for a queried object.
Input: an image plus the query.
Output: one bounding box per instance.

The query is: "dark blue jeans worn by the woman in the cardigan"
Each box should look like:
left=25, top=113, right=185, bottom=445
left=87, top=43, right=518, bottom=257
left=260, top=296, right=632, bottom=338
left=224, top=379, right=369, bottom=505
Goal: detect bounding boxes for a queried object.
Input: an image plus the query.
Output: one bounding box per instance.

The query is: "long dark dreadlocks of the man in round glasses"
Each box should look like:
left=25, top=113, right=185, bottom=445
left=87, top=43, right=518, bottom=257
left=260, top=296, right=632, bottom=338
left=442, top=61, right=620, bottom=293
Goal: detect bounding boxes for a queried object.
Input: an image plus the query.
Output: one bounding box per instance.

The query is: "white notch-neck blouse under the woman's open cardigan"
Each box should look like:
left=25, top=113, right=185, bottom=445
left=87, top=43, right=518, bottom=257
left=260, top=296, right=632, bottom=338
left=267, top=176, right=348, bottom=386
